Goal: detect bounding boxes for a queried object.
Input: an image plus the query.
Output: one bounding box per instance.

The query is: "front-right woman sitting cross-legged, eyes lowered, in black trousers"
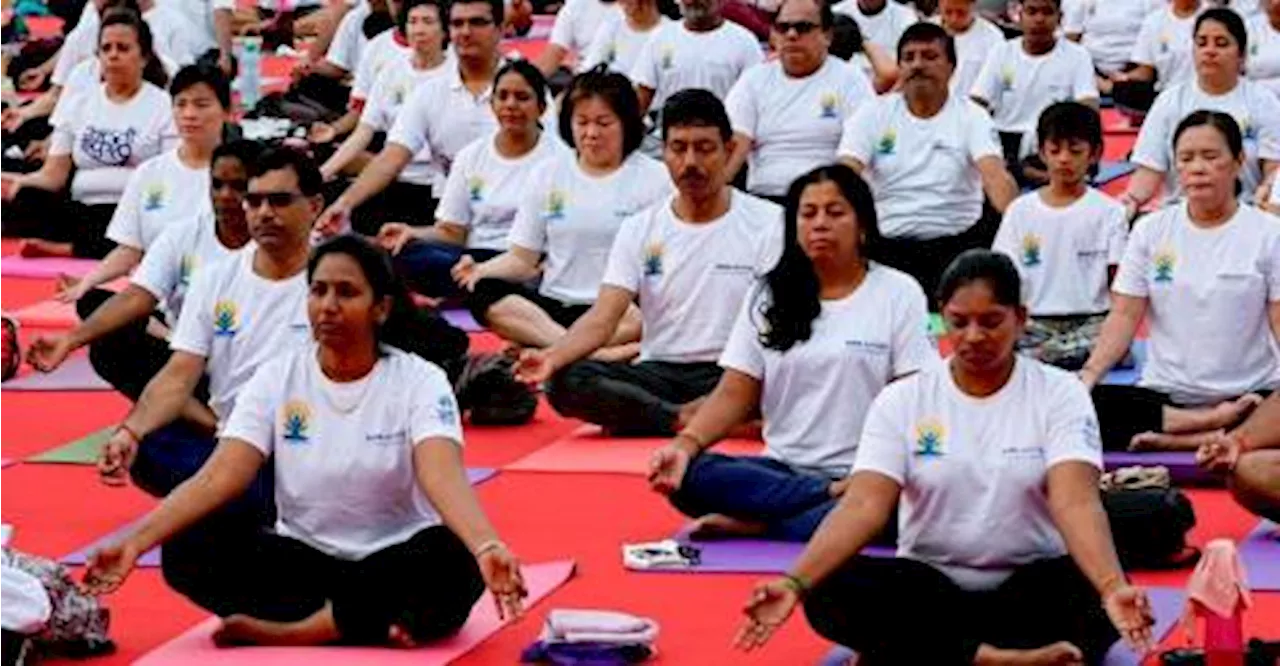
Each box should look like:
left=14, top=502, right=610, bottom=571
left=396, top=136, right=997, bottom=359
left=737, top=250, right=1152, bottom=666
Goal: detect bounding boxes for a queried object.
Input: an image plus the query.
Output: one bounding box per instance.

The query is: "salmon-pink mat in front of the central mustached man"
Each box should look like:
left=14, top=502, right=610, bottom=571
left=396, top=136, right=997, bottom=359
left=503, top=425, right=763, bottom=475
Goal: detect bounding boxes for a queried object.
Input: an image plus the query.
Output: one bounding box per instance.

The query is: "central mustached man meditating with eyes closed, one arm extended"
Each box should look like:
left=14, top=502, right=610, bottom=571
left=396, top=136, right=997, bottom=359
left=516, top=88, right=782, bottom=437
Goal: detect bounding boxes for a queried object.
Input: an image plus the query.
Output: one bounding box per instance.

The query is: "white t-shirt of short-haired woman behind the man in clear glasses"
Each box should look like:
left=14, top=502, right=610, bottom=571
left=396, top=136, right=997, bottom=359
left=360, top=54, right=458, bottom=188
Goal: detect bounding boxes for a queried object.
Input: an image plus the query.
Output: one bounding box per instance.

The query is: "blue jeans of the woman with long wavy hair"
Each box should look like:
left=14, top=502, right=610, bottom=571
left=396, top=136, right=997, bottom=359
left=671, top=453, right=836, bottom=542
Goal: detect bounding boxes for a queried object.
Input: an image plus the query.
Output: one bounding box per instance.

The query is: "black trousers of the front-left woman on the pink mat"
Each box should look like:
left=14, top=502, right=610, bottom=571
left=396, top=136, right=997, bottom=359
left=164, top=525, right=484, bottom=646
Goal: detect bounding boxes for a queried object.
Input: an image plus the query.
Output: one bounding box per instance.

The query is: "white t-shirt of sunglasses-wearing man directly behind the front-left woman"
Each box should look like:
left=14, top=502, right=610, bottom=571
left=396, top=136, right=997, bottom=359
left=169, top=243, right=311, bottom=424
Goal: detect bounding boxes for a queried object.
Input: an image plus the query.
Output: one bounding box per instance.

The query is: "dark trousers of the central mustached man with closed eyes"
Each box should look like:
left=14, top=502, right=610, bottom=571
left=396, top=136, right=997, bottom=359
left=547, top=361, right=723, bottom=437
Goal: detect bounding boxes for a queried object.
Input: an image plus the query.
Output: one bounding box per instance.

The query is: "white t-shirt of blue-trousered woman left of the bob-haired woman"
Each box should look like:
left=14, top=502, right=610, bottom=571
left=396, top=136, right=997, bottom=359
left=435, top=131, right=566, bottom=252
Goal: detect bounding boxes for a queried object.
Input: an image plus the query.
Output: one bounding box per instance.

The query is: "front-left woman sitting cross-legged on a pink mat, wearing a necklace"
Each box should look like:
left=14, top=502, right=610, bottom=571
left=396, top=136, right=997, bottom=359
left=84, top=236, right=525, bottom=647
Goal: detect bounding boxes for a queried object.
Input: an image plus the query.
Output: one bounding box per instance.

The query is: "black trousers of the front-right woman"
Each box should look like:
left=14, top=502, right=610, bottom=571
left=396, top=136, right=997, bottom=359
left=804, top=556, right=1119, bottom=666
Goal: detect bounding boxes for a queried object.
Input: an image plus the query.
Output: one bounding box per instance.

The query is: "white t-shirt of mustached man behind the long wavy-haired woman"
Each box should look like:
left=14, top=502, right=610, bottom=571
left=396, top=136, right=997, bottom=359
left=837, top=92, right=1004, bottom=240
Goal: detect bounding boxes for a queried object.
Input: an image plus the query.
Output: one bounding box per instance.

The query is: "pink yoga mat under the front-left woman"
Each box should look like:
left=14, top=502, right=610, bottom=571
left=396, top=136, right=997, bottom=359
left=133, top=560, right=573, bottom=666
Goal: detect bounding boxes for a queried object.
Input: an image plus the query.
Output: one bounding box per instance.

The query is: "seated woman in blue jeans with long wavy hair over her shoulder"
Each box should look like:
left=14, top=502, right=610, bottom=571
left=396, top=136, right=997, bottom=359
left=650, top=165, right=937, bottom=542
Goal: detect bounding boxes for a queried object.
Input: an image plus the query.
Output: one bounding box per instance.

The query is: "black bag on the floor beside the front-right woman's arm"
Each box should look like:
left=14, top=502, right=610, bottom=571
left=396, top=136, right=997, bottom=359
left=1102, top=488, right=1199, bottom=570
